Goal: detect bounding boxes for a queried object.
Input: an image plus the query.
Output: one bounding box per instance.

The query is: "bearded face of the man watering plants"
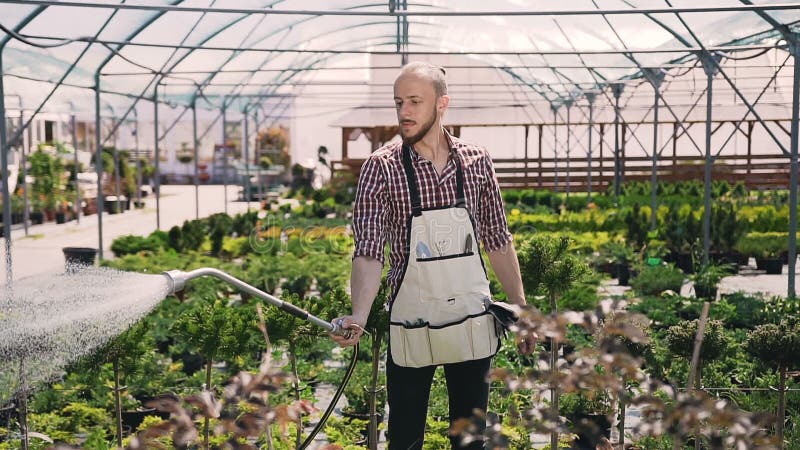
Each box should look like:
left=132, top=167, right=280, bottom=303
left=394, top=74, right=439, bottom=145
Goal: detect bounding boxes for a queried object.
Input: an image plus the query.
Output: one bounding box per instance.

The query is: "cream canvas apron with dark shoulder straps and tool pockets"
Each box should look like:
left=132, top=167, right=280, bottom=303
left=389, top=145, right=500, bottom=367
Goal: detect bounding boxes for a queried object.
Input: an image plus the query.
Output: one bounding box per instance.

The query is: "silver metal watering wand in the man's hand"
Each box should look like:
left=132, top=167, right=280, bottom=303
left=164, top=267, right=353, bottom=338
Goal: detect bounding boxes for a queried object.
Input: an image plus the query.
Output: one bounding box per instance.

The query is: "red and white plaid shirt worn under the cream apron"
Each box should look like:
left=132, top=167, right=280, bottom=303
left=353, top=136, right=511, bottom=292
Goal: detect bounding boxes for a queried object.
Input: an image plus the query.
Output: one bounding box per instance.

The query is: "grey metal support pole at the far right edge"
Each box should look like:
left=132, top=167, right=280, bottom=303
left=778, top=38, right=800, bottom=298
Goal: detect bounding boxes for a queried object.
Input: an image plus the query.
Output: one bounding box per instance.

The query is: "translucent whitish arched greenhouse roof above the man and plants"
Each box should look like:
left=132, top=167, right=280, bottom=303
left=0, top=0, right=800, bottom=117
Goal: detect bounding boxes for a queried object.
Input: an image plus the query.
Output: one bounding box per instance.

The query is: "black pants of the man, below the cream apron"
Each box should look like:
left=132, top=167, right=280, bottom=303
left=386, top=351, right=492, bottom=450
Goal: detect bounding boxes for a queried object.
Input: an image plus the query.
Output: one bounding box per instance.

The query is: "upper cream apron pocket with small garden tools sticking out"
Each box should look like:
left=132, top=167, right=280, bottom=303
left=416, top=252, right=486, bottom=301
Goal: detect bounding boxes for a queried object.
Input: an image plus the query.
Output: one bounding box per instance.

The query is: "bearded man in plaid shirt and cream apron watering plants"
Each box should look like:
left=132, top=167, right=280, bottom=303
left=333, top=63, right=536, bottom=450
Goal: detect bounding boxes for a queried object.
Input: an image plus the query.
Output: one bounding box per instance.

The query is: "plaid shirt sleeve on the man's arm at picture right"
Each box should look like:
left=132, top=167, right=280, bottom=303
left=477, top=154, right=512, bottom=252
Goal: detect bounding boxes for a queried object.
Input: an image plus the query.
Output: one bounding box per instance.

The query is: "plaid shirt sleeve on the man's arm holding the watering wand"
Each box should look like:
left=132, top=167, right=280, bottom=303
left=353, top=157, right=389, bottom=264
